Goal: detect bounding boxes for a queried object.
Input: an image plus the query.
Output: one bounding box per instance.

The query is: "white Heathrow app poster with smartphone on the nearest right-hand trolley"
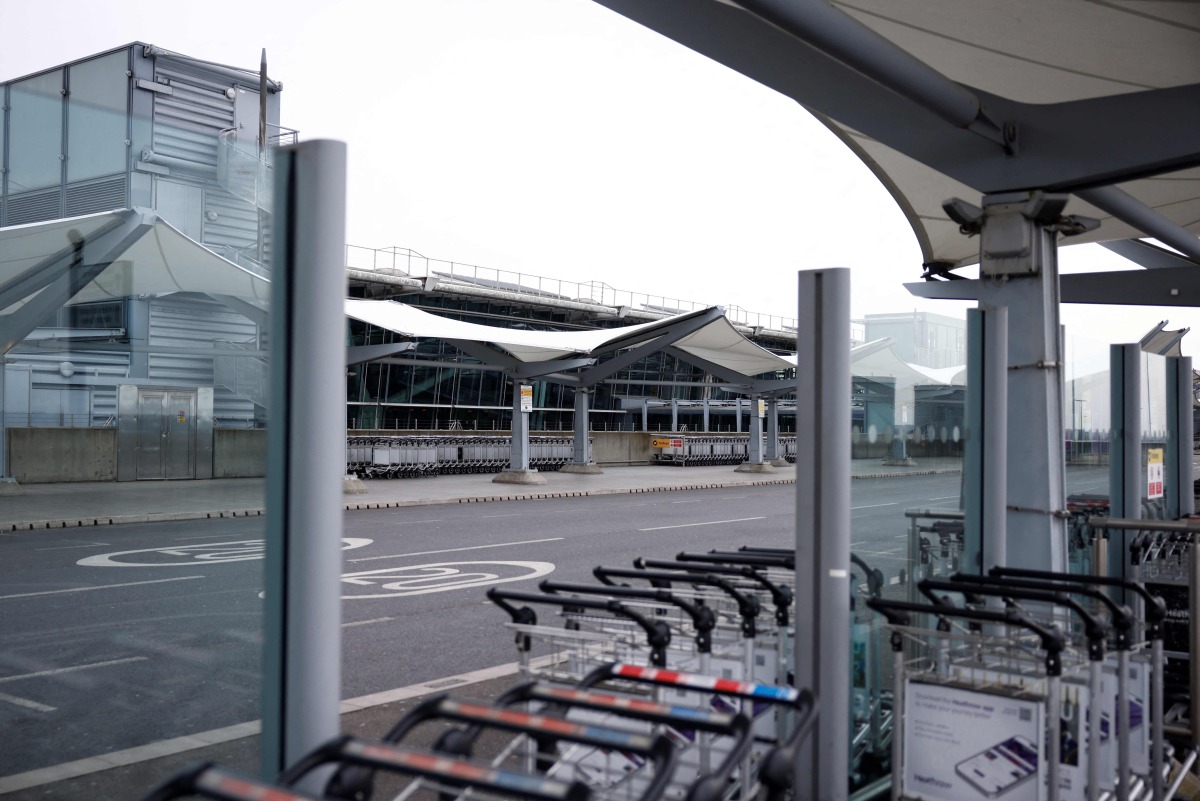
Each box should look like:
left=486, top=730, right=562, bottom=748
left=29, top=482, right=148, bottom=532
left=901, top=680, right=1045, bottom=801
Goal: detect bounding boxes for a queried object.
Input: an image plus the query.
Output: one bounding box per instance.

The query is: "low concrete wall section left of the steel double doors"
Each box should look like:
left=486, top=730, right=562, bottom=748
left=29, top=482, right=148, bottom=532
left=6, top=428, right=116, bottom=484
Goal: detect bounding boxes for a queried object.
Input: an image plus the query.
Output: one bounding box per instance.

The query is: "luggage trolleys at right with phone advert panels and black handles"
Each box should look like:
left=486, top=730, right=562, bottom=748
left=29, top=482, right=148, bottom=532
left=866, top=568, right=1195, bottom=801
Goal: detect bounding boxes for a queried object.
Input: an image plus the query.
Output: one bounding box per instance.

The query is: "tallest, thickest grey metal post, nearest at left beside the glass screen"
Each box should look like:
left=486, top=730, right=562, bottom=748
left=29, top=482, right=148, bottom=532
left=262, top=140, right=346, bottom=778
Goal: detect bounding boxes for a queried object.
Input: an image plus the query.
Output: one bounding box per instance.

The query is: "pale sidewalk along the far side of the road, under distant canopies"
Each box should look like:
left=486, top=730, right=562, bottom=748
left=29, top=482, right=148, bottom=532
left=0, top=458, right=962, bottom=534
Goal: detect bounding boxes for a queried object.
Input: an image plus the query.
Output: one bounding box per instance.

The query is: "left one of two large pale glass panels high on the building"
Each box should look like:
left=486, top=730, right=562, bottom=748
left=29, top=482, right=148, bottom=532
left=8, top=70, right=62, bottom=194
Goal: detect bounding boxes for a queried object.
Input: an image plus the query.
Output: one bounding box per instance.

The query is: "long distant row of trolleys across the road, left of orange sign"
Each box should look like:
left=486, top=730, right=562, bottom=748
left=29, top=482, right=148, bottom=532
left=346, top=434, right=575, bottom=478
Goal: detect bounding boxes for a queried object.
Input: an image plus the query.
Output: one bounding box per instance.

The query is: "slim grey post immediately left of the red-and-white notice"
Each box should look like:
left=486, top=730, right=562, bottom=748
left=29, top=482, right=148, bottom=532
left=1109, top=344, right=1141, bottom=578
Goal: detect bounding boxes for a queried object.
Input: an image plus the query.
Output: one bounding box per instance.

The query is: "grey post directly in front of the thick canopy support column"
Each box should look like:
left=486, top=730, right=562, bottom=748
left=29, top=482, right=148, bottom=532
left=962, top=307, right=1008, bottom=574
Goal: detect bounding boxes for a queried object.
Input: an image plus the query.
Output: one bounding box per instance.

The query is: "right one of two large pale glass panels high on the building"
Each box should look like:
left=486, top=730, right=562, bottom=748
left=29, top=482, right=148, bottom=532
left=67, top=50, right=130, bottom=181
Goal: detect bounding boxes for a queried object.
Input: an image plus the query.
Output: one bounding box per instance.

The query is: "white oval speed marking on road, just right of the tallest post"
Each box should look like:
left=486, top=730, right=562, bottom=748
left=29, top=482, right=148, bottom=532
left=342, top=561, right=554, bottom=601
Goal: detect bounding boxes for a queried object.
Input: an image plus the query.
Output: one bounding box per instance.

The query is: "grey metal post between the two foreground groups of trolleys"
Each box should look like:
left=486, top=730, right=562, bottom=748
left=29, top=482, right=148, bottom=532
left=796, top=267, right=851, bottom=801
